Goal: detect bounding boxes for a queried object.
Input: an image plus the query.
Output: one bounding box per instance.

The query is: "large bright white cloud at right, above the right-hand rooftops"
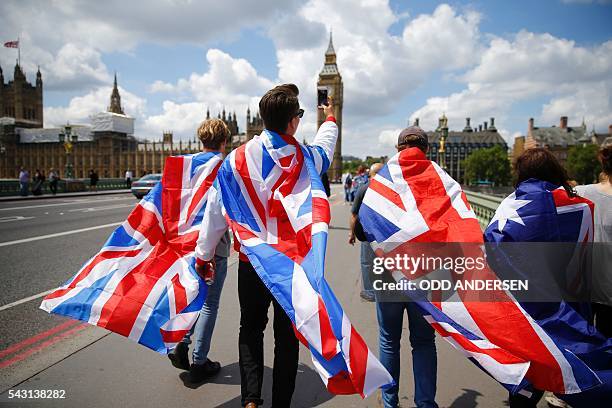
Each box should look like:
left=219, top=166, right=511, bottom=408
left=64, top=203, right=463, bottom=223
left=411, top=31, right=612, bottom=140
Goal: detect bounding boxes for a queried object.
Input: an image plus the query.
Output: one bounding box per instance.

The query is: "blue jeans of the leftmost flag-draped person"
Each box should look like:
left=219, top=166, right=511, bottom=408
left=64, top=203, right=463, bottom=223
left=181, top=255, right=227, bottom=364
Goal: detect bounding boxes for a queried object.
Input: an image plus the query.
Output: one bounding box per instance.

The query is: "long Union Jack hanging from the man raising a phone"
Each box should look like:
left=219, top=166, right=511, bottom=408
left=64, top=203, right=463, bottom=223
left=218, top=120, right=393, bottom=397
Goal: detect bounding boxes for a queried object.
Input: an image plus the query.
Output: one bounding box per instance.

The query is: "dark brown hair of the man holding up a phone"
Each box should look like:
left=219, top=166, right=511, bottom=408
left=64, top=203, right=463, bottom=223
left=259, top=84, right=300, bottom=133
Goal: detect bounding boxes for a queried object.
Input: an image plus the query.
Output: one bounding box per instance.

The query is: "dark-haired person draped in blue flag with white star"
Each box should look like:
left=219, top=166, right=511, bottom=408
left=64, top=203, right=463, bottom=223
left=484, top=148, right=612, bottom=408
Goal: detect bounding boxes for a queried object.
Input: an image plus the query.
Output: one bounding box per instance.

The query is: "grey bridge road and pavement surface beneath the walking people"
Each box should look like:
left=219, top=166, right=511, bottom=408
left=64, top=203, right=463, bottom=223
left=0, top=186, right=546, bottom=408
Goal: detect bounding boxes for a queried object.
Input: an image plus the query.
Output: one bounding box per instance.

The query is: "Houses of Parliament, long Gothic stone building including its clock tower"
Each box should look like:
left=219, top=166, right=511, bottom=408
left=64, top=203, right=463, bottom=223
left=0, top=37, right=342, bottom=180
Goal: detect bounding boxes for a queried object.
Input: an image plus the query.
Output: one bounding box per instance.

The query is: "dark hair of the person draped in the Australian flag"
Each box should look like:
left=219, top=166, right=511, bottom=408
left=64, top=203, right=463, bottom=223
left=514, top=147, right=576, bottom=197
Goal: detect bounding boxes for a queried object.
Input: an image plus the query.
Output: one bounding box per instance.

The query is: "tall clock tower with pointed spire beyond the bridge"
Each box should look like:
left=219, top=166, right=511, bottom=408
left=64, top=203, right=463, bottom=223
left=317, top=33, right=344, bottom=181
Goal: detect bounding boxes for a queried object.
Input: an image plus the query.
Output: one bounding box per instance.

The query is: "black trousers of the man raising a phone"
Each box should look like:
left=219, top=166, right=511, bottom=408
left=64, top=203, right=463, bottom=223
left=238, top=261, right=299, bottom=408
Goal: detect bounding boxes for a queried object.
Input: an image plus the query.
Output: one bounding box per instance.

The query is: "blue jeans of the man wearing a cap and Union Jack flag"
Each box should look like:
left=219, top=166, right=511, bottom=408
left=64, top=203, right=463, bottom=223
left=376, top=302, right=438, bottom=408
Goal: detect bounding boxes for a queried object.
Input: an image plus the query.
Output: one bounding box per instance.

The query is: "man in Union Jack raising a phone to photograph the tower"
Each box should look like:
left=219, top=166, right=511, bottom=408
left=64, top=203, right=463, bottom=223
left=196, top=84, right=392, bottom=407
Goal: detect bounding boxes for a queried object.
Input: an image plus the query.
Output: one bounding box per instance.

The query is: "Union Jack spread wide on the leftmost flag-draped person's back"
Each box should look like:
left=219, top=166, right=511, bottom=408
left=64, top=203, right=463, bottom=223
left=40, top=153, right=222, bottom=353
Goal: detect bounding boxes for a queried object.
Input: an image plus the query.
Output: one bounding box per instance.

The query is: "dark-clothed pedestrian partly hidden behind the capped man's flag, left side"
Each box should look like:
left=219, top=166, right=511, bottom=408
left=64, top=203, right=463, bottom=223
left=349, top=163, right=383, bottom=302
